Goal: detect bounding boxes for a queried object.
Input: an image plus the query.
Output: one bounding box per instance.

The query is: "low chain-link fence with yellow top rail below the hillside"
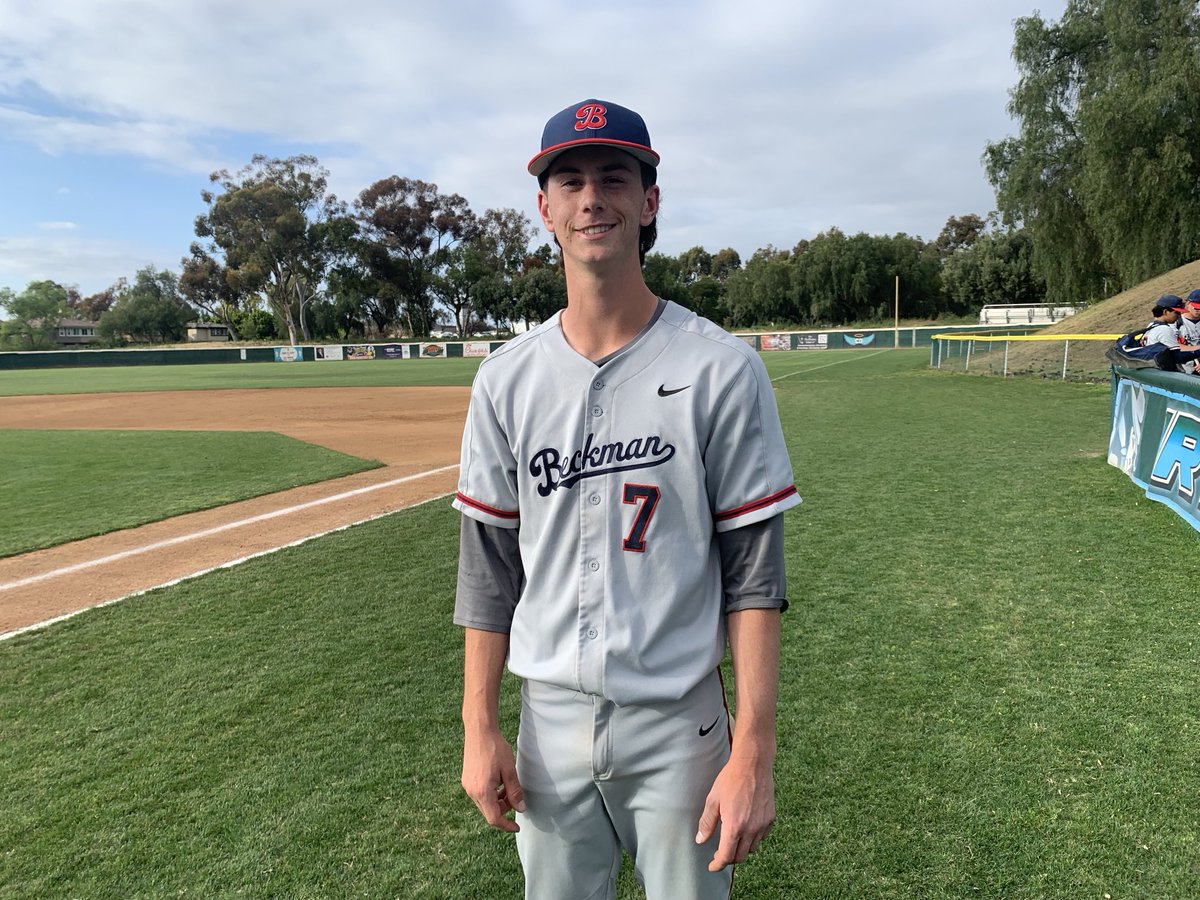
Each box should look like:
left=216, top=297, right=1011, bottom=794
left=929, top=331, right=1121, bottom=380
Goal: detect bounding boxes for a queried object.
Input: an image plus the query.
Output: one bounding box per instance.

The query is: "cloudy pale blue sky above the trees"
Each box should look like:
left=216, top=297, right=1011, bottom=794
left=0, top=0, right=1066, bottom=294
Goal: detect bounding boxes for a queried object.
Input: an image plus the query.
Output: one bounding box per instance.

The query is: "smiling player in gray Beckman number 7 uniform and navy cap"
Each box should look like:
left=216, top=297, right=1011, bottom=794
left=454, top=100, right=800, bottom=900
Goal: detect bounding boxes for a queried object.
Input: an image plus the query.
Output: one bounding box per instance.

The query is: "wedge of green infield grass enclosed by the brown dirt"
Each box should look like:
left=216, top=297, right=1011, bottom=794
left=0, top=430, right=380, bottom=557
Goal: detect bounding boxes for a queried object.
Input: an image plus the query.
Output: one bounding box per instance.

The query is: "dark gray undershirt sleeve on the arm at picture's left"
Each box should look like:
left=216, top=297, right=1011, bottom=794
left=454, top=516, right=524, bottom=634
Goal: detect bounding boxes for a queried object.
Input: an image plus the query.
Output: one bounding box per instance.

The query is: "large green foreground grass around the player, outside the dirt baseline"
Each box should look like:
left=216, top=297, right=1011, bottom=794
left=0, top=350, right=1200, bottom=900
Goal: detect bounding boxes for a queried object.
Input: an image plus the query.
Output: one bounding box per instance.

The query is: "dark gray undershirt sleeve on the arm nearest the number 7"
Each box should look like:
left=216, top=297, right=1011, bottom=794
left=716, top=515, right=787, bottom=613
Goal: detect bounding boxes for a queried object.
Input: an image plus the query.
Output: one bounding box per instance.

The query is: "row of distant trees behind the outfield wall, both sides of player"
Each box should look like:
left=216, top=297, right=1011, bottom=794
left=0, top=156, right=1044, bottom=349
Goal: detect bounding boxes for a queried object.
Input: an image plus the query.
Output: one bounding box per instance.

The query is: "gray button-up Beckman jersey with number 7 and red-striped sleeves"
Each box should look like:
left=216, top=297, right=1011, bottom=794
left=454, top=304, right=800, bottom=704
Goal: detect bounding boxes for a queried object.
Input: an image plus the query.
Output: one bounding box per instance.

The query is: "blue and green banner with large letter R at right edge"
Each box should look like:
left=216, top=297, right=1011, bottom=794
left=1109, top=378, right=1200, bottom=530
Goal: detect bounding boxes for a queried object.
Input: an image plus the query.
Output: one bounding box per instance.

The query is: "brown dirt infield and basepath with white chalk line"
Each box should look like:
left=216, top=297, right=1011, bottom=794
left=0, top=388, right=469, bottom=637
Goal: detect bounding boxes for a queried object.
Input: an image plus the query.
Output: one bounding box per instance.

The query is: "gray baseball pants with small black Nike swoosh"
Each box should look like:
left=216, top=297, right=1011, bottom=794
left=517, top=671, right=732, bottom=900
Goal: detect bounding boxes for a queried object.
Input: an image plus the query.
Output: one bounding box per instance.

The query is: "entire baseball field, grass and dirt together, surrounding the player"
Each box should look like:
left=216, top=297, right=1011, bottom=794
left=0, top=349, right=1200, bottom=900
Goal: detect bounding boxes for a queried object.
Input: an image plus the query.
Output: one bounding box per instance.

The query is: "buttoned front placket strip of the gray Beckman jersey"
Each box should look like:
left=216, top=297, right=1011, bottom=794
left=576, top=370, right=612, bottom=694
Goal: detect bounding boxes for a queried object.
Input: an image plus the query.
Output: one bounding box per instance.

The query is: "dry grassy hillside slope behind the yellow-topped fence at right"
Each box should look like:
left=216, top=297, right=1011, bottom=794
left=1009, top=259, right=1200, bottom=376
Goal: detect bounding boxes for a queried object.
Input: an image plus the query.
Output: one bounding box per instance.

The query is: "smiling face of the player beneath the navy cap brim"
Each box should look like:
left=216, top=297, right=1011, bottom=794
left=538, top=146, right=659, bottom=273
